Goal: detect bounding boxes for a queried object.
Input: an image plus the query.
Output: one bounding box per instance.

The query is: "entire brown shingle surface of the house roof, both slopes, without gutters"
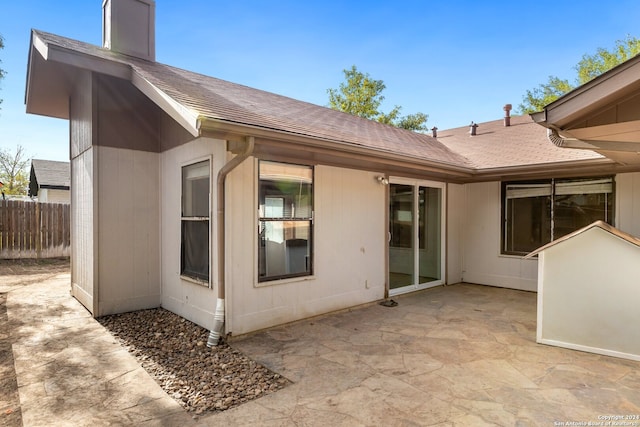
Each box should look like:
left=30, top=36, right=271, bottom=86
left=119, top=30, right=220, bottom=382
left=34, top=31, right=603, bottom=171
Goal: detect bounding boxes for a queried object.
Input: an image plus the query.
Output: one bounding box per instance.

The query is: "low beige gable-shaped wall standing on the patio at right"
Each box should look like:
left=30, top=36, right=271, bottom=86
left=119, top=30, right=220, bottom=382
left=537, top=228, right=640, bottom=360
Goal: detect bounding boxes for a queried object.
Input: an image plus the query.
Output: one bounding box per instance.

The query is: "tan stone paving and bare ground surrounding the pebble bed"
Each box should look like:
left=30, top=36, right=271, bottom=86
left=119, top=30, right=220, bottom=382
left=0, top=264, right=640, bottom=426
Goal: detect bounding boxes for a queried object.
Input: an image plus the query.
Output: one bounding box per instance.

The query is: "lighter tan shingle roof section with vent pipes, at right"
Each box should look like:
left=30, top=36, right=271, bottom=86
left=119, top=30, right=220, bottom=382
left=438, top=116, right=605, bottom=169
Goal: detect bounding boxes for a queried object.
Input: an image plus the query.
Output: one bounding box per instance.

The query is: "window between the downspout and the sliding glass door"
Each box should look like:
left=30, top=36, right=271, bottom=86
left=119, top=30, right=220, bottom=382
left=258, top=161, right=313, bottom=282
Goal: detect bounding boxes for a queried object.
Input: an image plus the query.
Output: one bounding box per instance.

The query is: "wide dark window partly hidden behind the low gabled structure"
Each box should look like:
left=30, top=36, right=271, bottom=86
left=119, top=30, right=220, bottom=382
left=502, top=177, right=614, bottom=255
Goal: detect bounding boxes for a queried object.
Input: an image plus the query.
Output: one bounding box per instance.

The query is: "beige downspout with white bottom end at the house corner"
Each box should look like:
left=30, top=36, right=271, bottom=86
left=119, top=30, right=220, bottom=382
left=207, top=136, right=255, bottom=347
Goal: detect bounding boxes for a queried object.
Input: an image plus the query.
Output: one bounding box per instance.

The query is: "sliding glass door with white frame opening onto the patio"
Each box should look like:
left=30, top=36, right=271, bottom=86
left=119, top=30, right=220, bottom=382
left=389, top=179, right=444, bottom=295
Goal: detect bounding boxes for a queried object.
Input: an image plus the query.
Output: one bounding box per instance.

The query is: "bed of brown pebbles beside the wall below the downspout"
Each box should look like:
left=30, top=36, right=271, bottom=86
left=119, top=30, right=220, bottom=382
left=98, top=308, right=289, bottom=415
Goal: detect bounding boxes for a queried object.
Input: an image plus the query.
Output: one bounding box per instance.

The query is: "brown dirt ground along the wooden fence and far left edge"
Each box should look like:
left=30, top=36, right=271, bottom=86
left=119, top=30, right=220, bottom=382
left=0, top=258, right=69, bottom=427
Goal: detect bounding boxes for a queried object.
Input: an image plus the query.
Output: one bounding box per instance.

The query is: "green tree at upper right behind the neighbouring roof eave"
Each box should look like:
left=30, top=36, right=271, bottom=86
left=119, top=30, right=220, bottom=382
left=518, top=36, right=640, bottom=114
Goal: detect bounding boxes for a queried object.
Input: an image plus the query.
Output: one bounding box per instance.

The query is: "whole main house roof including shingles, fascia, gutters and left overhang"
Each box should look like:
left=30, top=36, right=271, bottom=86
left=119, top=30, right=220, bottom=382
left=26, top=30, right=636, bottom=182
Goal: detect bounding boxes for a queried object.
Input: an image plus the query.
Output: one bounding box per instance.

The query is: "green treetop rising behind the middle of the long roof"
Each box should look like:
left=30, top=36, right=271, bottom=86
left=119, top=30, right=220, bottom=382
left=327, top=65, right=428, bottom=132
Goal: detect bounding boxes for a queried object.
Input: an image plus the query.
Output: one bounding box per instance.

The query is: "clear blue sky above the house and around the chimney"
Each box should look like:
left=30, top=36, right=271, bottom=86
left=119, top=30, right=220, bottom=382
left=0, top=0, right=640, bottom=160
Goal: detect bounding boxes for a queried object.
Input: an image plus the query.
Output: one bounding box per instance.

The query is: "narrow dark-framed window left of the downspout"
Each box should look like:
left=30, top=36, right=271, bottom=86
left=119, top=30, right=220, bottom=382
left=180, top=160, right=210, bottom=284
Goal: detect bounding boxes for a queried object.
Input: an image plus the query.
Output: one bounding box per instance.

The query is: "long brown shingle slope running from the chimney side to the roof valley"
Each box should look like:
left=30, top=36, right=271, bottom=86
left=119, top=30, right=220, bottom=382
left=34, top=31, right=468, bottom=167
